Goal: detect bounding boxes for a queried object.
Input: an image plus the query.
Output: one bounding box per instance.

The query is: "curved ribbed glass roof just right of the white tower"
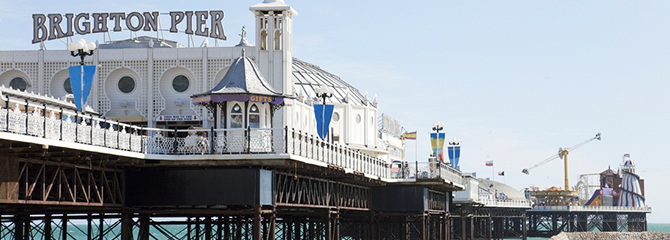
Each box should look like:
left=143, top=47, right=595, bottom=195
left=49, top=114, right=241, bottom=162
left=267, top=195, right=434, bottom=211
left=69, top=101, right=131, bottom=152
left=292, top=58, right=366, bottom=106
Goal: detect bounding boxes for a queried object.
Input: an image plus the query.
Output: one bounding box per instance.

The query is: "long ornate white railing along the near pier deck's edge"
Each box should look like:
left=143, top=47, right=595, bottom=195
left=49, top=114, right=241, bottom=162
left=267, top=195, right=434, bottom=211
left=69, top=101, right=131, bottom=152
left=0, top=99, right=461, bottom=185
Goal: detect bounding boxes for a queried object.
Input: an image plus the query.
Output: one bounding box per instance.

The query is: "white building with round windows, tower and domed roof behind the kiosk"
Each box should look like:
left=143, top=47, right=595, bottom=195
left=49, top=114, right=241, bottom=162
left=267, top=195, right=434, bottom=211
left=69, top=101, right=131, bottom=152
left=0, top=1, right=403, bottom=161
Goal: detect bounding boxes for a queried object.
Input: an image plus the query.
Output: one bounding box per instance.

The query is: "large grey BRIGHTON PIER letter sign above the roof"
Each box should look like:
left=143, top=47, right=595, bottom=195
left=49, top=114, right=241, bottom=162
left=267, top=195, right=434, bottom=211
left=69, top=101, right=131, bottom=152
left=33, top=11, right=226, bottom=43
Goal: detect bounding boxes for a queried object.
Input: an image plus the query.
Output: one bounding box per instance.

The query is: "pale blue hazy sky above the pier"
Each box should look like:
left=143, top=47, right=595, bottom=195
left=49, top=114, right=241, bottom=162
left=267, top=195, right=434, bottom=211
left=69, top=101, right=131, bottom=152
left=0, top=0, right=670, bottom=223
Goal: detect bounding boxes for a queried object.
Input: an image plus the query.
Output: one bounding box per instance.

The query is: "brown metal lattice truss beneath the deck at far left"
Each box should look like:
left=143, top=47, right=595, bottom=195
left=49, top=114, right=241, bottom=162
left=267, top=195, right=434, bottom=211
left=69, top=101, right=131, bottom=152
left=0, top=158, right=124, bottom=207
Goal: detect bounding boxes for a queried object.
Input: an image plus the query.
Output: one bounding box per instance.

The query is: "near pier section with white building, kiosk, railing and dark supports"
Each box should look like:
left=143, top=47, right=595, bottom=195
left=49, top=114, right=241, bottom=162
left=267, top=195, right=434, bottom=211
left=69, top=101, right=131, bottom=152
left=0, top=0, right=463, bottom=240
